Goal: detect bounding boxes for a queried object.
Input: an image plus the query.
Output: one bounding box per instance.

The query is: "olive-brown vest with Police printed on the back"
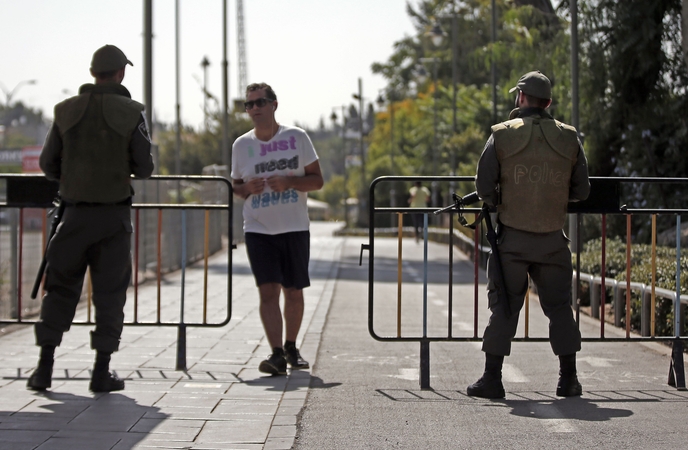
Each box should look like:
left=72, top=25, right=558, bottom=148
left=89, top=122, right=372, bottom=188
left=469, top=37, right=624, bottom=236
left=492, top=116, right=579, bottom=233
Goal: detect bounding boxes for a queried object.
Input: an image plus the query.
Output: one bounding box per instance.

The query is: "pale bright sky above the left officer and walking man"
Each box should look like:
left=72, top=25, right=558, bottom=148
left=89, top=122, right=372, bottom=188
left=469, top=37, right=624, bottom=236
left=0, top=0, right=417, bottom=132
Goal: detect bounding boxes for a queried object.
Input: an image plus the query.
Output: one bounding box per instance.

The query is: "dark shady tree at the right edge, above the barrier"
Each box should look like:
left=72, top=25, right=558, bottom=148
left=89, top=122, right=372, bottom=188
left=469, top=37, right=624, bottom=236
left=579, top=0, right=688, bottom=195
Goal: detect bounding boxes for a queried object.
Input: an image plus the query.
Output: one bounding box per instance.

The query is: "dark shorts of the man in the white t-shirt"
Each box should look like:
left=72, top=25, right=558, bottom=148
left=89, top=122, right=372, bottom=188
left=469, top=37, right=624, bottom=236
left=244, top=231, right=311, bottom=289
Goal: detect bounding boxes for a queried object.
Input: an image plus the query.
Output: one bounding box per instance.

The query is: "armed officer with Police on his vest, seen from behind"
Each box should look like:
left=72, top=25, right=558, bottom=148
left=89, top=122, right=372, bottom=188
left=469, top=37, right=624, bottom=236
left=467, top=71, right=590, bottom=398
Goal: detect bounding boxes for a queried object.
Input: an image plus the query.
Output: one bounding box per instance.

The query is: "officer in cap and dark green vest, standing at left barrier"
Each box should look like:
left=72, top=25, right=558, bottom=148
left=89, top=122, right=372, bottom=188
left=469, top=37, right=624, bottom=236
left=27, top=45, right=153, bottom=392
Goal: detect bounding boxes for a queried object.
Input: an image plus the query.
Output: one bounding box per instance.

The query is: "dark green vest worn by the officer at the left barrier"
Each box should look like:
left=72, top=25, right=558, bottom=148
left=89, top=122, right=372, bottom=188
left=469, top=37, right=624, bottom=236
left=55, top=86, right=143, bottom=203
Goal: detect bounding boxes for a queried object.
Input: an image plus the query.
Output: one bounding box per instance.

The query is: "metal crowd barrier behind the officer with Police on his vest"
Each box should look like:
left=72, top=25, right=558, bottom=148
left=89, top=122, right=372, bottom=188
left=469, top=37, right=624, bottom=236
left=359, top=176, right=688, bottom=390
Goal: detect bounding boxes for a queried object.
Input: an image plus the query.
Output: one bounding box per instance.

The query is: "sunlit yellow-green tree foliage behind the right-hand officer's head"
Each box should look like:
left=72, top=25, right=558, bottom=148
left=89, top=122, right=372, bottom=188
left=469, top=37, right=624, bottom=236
left=368, top=0, right=570, bottom=197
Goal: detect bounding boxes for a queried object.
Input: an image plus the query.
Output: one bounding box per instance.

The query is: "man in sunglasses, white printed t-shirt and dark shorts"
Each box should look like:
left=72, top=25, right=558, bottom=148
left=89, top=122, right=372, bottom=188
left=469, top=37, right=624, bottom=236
left=231, top=83, right=323, bottom=375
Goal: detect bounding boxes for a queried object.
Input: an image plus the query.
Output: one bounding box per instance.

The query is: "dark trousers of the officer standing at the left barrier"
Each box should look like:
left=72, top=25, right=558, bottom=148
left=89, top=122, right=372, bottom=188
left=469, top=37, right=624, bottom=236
left=35, top=205, right=132, bottom=353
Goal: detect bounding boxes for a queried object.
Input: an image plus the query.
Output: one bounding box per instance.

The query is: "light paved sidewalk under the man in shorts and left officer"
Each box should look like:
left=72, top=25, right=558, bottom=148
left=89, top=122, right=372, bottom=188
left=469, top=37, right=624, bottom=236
left=0, top=223, right=344, bottom=450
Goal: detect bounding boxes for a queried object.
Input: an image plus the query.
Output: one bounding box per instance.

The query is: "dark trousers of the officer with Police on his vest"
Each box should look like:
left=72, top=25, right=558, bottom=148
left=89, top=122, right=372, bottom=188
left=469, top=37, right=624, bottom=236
left=482, top=226, right=581, bottom=356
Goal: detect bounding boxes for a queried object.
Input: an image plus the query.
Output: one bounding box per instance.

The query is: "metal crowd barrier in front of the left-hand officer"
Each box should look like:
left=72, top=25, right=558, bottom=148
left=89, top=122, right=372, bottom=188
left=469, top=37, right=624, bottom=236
left=0, top=174, right=233, bottom=370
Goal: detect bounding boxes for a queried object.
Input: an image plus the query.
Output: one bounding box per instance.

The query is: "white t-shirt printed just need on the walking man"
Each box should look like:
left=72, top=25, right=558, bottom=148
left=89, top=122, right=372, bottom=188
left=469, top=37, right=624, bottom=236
left=230, top=125, right=318, bottom=234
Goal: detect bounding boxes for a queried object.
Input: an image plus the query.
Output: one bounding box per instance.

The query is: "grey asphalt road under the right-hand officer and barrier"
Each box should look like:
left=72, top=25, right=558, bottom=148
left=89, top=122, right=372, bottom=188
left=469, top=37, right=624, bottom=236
left=294, top=232, right=688, bottom=449
